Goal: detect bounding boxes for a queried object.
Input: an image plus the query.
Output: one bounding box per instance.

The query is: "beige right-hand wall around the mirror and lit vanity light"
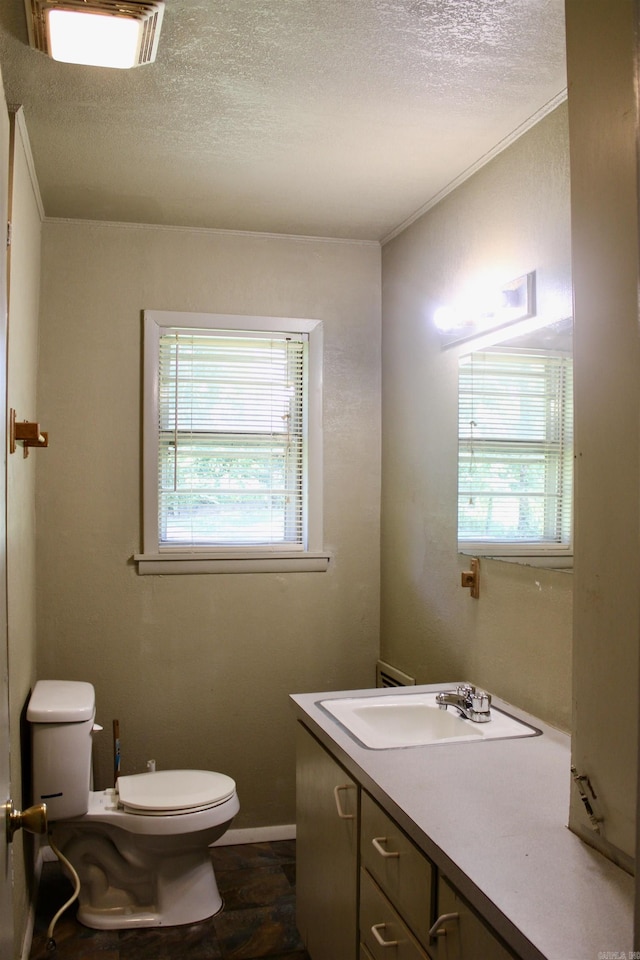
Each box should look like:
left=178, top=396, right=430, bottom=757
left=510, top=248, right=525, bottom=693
left=381, top=106, right=573, bottom=729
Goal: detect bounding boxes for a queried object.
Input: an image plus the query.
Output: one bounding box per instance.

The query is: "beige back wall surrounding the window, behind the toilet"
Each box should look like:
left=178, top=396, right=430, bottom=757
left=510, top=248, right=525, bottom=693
left=37, top=222, right=380, bottom=827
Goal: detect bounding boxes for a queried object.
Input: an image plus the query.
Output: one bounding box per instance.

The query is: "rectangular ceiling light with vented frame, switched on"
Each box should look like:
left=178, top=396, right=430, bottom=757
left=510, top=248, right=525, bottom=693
left=24, top=0, right=164, bottom=70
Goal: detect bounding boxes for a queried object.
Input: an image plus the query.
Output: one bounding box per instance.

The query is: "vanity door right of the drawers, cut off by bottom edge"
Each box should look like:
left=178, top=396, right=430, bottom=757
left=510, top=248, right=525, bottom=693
left=436, top=877, right=517, bottom=960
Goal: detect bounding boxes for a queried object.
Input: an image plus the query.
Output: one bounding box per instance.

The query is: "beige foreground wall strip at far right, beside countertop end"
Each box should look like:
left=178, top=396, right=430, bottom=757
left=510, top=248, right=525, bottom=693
left=566, top=0, right=640, bottom=864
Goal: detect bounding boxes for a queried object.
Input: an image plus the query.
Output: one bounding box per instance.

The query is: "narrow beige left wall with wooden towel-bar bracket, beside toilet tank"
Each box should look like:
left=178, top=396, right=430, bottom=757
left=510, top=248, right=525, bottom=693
left=7, top=110, right=46, bottom=956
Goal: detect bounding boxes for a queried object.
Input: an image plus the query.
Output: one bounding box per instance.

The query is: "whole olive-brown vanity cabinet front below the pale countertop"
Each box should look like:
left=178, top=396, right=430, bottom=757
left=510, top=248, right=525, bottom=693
left=296, top=723, right=517, bottom=960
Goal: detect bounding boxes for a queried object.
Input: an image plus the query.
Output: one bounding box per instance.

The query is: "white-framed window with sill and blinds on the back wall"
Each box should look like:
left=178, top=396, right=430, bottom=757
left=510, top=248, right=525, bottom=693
left=137, top=311, right=327, bottom=573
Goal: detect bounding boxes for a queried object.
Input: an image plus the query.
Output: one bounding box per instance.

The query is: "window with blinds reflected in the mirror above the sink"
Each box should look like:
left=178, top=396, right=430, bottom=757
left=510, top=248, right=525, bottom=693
left=458, top=348, right=573, bottom=556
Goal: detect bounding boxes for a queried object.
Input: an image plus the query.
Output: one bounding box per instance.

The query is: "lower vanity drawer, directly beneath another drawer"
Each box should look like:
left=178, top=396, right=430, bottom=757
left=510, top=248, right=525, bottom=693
left=360, top=870, right=430, bottom=960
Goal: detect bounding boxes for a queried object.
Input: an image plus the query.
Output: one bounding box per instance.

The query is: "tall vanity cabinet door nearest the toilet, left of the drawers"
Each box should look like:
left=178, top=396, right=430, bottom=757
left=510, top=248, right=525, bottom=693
left=296, top=724, right=359, bottom=960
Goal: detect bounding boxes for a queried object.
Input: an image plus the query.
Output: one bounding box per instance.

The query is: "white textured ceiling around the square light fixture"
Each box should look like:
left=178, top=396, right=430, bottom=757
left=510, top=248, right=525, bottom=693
left=0, top=0, right=566, bottom=240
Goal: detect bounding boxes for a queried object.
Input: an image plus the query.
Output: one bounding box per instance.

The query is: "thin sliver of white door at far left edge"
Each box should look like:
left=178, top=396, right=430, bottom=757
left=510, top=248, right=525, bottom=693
left=0, top=85, right=14, bottom=958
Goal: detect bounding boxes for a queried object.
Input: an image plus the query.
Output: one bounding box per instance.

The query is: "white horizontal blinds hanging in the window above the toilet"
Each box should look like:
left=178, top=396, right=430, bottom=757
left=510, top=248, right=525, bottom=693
left=158, top=328, right=307, bottom=550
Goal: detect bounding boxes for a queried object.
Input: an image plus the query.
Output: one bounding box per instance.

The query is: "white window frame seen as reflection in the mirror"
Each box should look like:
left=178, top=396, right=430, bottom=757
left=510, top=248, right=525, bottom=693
left=456, top=344, right=574, bottom=567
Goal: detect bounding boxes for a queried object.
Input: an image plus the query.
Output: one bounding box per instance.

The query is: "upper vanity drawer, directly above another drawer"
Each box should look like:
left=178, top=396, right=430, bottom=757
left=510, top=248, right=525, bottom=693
left=360, top=791, right=433, bottom=952
